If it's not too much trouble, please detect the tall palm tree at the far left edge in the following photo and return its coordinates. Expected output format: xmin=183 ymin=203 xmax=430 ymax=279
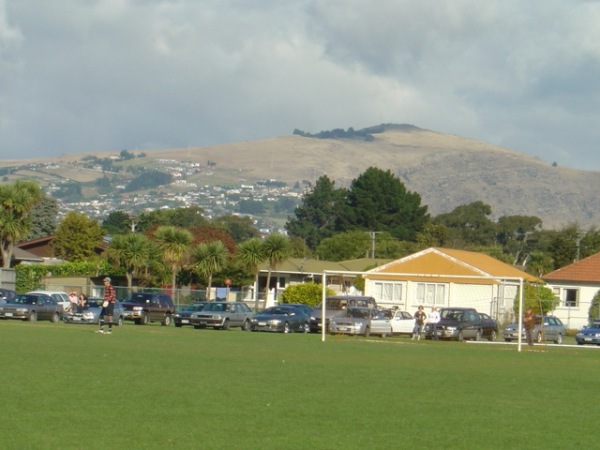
xmin=0 ymin=180 xmax=42 ymax=269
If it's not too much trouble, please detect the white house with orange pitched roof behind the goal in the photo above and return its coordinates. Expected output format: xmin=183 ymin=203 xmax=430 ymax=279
xmin=364 ymin=247 xmax=541 ymax=322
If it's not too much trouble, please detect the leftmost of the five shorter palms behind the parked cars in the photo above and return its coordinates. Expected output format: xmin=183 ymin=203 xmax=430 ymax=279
xmin=106 ymin=233 xmax=152 ymax=292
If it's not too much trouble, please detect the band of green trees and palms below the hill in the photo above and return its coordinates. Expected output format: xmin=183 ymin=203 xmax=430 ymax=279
xmin=0 ymin=167 xmax=600 ymax=294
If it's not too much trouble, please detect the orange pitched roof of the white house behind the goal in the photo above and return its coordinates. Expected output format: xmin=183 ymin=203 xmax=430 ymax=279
xmin=367 ymin=247 xmax=540 ymax=282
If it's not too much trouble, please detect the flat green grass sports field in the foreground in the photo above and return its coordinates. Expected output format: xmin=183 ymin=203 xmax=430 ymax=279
xmin=0 ymin=321 xmax=600 ymax=449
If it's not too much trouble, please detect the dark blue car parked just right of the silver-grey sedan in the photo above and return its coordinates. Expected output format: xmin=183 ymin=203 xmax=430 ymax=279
xmin=250 ymin=304 xmax=310 ymax=333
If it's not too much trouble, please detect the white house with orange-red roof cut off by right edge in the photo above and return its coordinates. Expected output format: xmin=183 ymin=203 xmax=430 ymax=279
xmin=542 ymin=253 xmax=600 ymax=328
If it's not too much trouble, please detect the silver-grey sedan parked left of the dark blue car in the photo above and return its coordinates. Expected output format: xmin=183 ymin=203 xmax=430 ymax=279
xmin=194 ymin=302 xmax=252 ymax=331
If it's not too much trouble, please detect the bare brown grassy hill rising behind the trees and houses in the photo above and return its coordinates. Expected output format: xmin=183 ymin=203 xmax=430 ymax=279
xmin=0 ymin=125 xmax=600 ymax=228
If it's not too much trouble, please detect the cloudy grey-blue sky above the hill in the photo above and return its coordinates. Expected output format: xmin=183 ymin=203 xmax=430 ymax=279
xmin=0 ymin=0 xmax=600 ymax=170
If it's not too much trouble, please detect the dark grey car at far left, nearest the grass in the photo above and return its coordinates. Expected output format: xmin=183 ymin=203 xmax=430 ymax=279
xmin=0 ymin=294 xmax=63 ymax=323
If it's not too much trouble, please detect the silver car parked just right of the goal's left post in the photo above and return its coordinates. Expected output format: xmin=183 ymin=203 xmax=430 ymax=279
xmin=329 ymin=307 xmax=392 ymax=337
